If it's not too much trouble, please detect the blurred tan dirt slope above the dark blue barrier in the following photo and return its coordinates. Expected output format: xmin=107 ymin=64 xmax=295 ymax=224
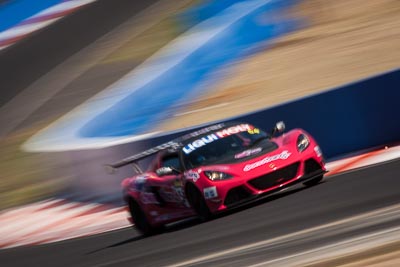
xmin=162 ymin=0 xmax=400 ymax=130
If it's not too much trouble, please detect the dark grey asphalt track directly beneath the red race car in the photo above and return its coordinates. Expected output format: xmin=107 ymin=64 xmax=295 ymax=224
xmin=0 ymin=160 xmax=400 ymax=266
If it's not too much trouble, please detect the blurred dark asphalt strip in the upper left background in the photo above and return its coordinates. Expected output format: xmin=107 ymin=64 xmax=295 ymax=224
xmin=0 ymin=0 xmax=157 ymax=107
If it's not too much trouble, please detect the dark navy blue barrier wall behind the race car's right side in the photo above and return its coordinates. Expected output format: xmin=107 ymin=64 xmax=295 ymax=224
xmin=240 ymin=70 xmax=400 ymax=158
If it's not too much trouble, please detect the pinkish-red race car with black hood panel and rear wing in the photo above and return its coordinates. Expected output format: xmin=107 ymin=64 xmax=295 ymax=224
xmin=109 ymin=122 xmax=326 ymax=235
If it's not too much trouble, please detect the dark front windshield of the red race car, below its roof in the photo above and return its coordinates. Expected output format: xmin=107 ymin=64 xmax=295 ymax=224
xmin=183 ymin=128 xmax=277 ymax=169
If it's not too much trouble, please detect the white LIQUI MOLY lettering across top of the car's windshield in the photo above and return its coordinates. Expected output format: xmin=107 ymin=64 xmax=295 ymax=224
xmin=182 ymin=124 xmax=255 ymax=154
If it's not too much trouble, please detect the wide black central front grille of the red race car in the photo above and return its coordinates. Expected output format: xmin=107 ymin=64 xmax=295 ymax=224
xmin=249 ymin=162 xmax=300 ymax=190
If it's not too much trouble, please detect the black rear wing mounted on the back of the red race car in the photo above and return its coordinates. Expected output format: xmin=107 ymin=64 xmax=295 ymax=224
xmin=105 ymin=141 xmax=181 ymax=173
